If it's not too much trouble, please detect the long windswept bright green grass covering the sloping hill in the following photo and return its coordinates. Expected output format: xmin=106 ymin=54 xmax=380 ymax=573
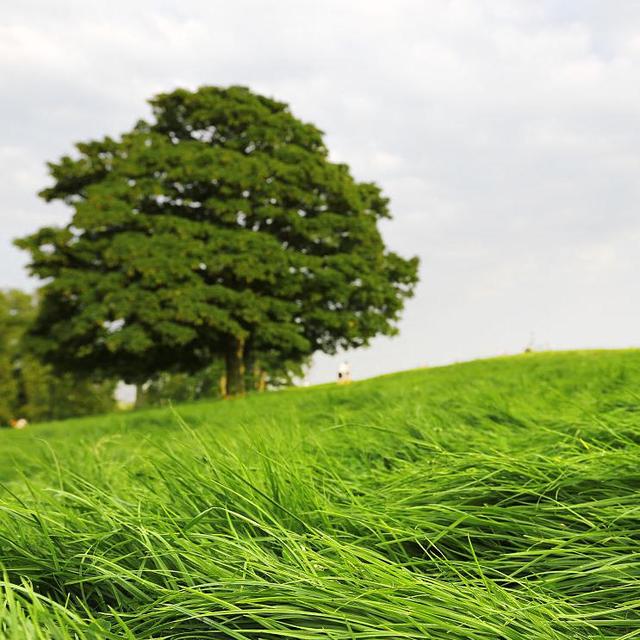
xmin=0 ymin=351 xmax=640 ymax=640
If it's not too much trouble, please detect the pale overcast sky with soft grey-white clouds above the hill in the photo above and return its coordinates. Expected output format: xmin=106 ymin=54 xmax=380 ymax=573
xmin=0 ymin=0 xmax=640 ymax=382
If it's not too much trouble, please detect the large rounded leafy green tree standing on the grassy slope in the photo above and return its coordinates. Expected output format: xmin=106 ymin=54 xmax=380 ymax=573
xmin=16 ymin=87 xmax=418 ymax=394
